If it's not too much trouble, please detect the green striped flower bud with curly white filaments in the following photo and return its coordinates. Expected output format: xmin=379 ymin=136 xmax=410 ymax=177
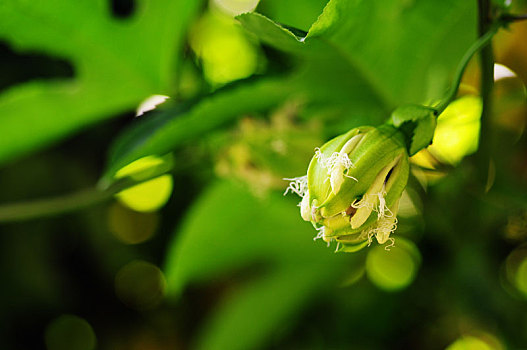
xmin=286 ymin=125 xmax=409 ymax=251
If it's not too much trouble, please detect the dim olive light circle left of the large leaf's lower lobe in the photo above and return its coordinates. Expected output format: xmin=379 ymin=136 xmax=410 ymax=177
xmin=115 ymin=260 xmax=166 ymax=310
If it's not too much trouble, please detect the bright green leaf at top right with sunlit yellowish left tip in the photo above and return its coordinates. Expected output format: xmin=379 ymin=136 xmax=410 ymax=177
xmin=305 ymin=0 xmax=477 ymax=105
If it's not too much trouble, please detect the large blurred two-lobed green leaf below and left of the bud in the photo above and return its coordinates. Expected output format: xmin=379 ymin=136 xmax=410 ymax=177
xmin=165 ymin=182 xmax=354 ymax=349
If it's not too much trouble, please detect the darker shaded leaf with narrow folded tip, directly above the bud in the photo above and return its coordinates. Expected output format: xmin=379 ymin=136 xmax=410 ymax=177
xmin=237 ymin=13 xmax=390 ymax=123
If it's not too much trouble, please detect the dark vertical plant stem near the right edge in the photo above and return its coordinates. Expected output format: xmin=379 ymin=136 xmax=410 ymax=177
xmin=477 ymin=0 xmax=500 ymax=192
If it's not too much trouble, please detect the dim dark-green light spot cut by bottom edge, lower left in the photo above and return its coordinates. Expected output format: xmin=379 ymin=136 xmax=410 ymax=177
xmin=44 ymin=315 xmax=97 ymax=350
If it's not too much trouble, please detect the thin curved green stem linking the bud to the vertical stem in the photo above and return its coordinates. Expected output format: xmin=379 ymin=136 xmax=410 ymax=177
xmin=435 ymin=21 xmax=502 ymax=115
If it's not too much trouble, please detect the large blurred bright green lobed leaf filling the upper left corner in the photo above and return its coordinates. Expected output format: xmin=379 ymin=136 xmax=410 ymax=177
xmin=0 ymin=0 xmax=201 ymax=163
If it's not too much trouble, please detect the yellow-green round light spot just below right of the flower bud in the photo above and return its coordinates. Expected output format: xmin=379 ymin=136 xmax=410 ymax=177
xmin=366 ymin=237 xmax=421 ymax=291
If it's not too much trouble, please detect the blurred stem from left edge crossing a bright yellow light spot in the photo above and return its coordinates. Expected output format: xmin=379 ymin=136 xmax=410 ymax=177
xmin=0 ymin=165 xmax=171 ymax=223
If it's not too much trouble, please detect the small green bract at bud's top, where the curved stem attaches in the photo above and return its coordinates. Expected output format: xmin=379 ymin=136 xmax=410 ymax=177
xmin=389 ymin=105 xmax=437 ymax=157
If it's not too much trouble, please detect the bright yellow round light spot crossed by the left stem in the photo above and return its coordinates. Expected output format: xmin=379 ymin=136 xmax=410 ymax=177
xmin=115 ymin=156 xmax=173 ymax=212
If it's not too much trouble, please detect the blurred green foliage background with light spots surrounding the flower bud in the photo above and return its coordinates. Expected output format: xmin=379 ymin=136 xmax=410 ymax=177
xmin=0 ymin=0 xmax=527 ymax=350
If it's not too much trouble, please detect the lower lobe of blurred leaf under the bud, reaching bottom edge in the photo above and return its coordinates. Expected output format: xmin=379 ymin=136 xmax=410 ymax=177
xmin=196 ymin=264 xmax=342 ymax=350
